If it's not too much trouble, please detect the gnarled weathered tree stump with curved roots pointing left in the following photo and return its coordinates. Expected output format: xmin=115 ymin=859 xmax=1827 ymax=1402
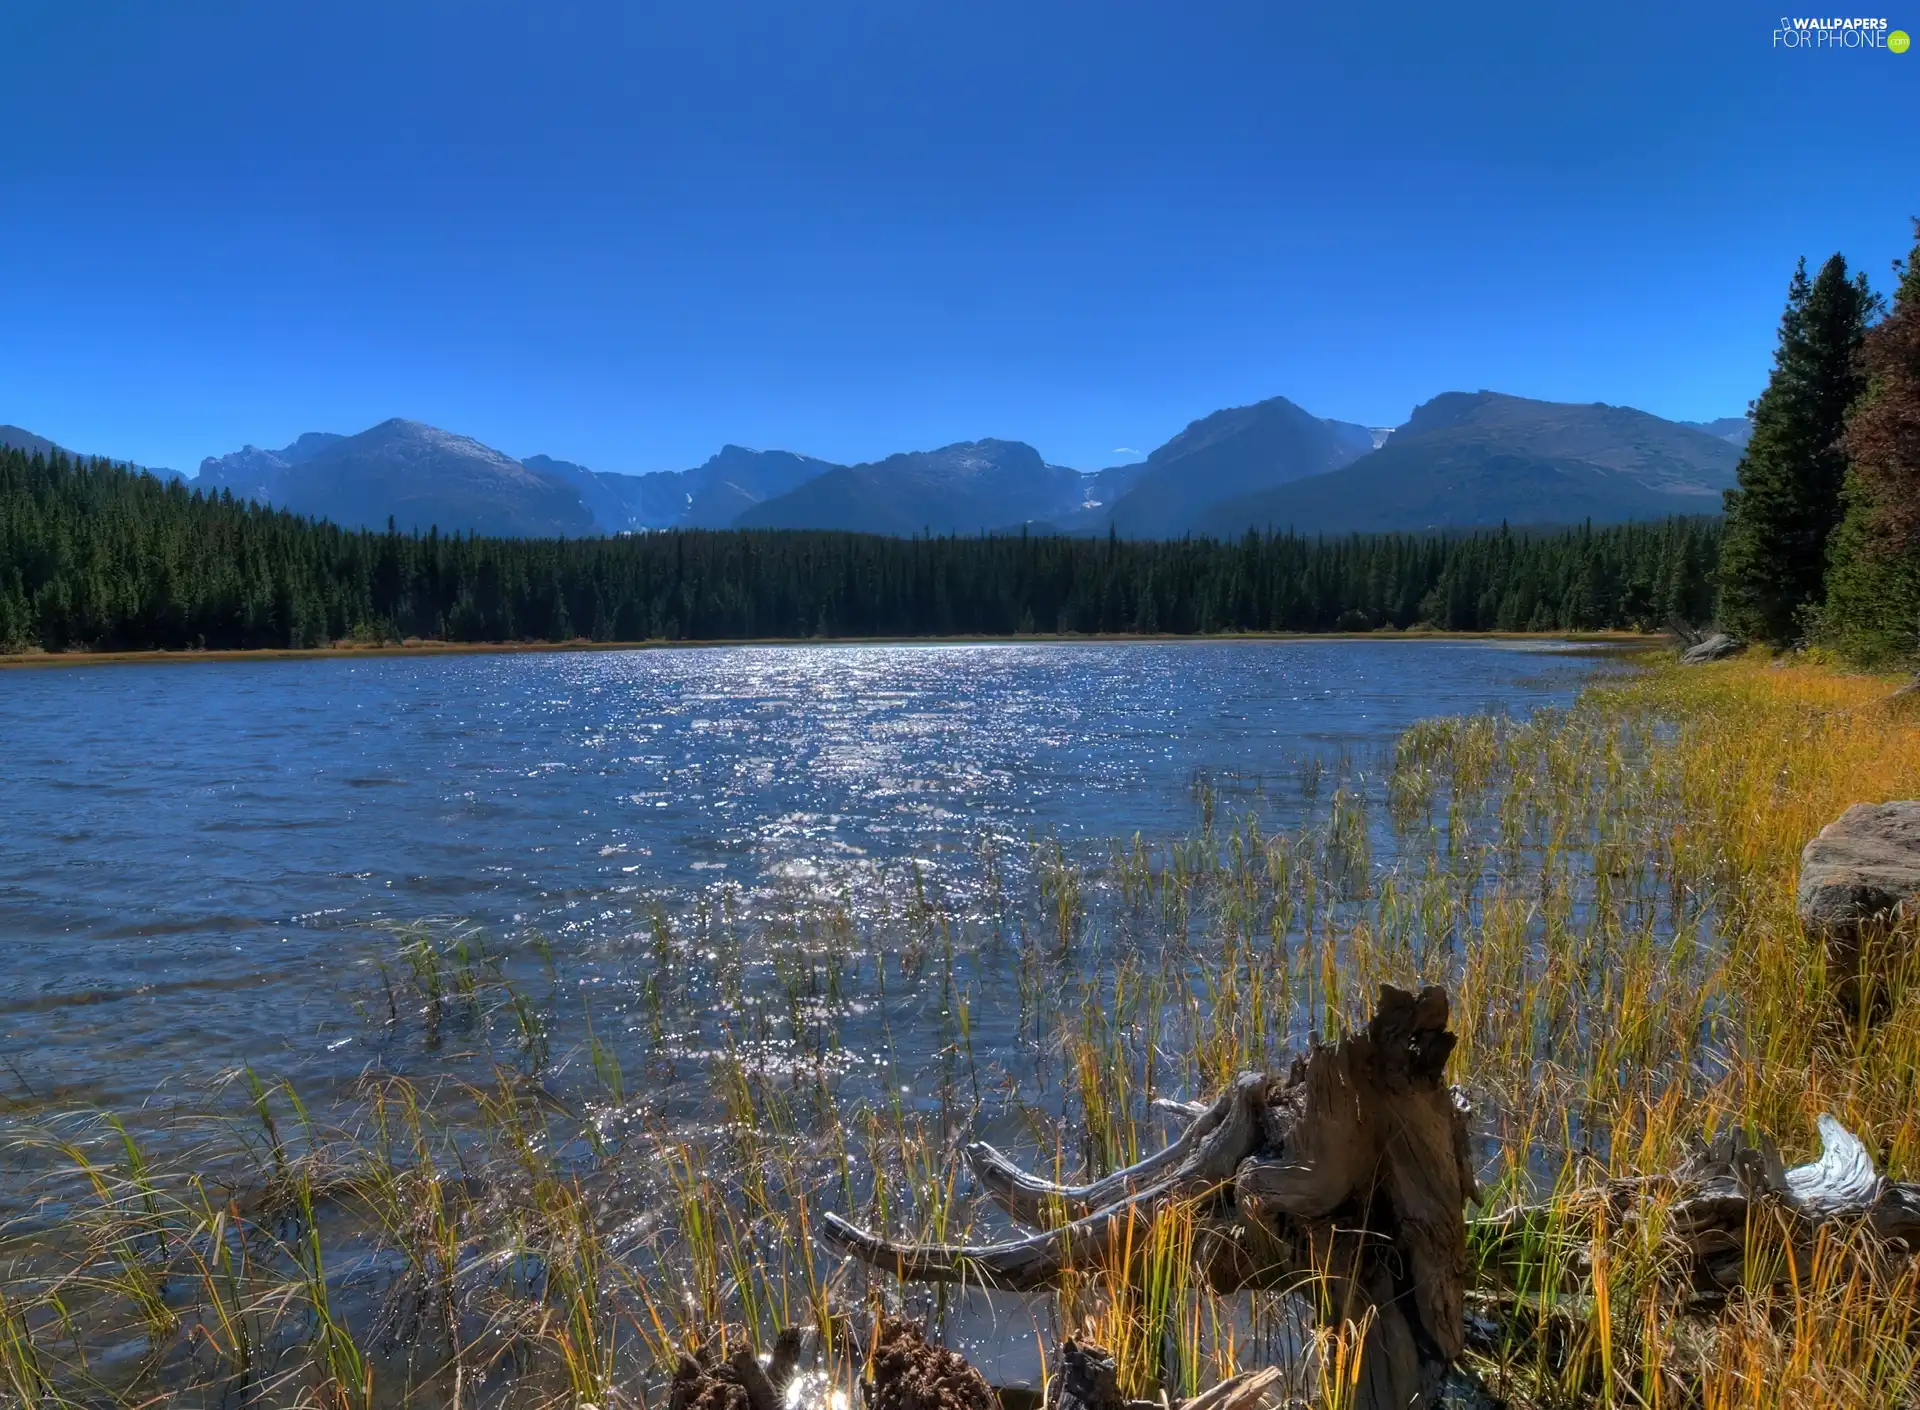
xmin=822 ymin=985 xmax=1475 ymax=1410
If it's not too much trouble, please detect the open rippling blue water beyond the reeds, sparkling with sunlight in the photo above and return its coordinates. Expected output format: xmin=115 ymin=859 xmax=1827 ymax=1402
xmin=0 ymin=642 xmax=1592 ymax=1106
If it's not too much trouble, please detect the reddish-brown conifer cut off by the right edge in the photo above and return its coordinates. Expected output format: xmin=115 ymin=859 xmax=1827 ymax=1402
xmin=1824 ymin=221 xmax=1920 ymax=665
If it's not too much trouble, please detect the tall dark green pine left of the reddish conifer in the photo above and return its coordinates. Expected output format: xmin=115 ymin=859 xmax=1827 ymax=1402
xmin=1720 ymin=255 xmax=1874 ymax=645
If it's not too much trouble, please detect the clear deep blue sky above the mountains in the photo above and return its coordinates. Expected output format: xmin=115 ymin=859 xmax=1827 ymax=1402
xmin=0 ymin=0 xmax=1920 ymax=471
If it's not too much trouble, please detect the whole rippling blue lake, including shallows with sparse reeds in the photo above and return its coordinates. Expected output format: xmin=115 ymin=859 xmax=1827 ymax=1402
xmin=0 ymin=642 xmax=1635 ymax=1404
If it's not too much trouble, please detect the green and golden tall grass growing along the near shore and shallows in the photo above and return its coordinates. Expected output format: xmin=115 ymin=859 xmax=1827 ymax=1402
xmin=0 ymin=661 xmax=1920 ymax=1406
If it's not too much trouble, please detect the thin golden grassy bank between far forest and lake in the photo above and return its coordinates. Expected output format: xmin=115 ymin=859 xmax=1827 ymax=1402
xmin=0 ymin=632 xmax=1665 ymax=670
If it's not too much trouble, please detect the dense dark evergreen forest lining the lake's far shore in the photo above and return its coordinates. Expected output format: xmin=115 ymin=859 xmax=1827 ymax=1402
xmin=0 ymin=451 xmax=1718 ymax=651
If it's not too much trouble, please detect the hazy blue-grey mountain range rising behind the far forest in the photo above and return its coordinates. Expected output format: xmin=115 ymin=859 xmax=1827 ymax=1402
xmin=0 ymin=392 xmax=1749 ymax=538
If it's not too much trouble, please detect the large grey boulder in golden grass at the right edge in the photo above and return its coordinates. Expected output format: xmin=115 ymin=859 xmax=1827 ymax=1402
xmin=1797 ymin=801 xmax=1920 ymax=997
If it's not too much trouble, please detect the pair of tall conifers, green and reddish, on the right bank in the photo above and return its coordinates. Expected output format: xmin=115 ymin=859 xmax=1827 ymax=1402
xmin=1720 ymin=223 xmax=1920 ymax=667
